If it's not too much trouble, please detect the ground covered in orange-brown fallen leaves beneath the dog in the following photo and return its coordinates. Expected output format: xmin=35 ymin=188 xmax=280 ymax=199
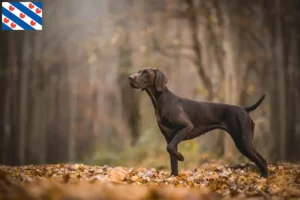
xmin=0 ymin=163 xmax=300 ymax=200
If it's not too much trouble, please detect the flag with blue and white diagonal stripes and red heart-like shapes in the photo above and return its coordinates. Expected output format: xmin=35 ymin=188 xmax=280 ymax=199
xmin=2 ymin=1 xmax=43 ymax=31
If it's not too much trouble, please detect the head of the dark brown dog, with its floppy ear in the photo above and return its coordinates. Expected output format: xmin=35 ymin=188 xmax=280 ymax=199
xmin=128 ymin=68 xmax=168 ymax=92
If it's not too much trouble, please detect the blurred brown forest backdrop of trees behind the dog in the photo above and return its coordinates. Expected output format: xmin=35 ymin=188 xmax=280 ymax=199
xmin=0 ymin=0 xmax=300 ymax=167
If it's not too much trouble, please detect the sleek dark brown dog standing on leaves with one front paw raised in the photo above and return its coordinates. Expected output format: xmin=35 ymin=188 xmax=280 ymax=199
xmin=128 ymin=68 xmax=268 ymax=178
